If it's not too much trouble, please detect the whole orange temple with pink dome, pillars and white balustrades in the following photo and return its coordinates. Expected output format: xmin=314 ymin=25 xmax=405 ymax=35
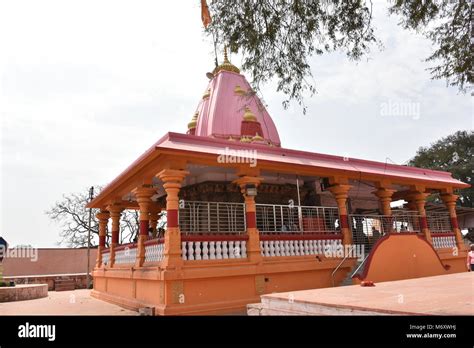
xmin=88 ymin=51 xmax=469 ymax=315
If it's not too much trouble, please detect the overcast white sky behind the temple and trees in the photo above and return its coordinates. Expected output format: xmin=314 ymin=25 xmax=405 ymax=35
xmin=0 ymin=0 xmax=473 ymax=247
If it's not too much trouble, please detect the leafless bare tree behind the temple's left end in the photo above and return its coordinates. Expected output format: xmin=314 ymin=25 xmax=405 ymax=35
xmin=46 ymin=186 xmax=143 ymax=248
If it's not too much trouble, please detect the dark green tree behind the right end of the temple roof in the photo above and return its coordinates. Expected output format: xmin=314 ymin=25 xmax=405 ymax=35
xmin=409 ymin=131 xmax=474 ymax=208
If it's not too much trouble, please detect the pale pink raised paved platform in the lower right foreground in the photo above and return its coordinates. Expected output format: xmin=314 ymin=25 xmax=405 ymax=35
xmin=249 ymin=272 xmax=474 ymax=315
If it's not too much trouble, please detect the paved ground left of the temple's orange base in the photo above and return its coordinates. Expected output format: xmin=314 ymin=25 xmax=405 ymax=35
xmin=0 ymin=290 xmax=138 ymax=315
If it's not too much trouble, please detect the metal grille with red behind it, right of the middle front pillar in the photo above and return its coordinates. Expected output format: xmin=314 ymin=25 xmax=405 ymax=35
xmin=256 ymin=204 xmax=339 ymax=233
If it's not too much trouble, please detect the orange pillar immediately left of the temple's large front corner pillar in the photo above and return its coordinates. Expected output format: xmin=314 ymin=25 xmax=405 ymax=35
xmin=134 ymin=185 xmax=156 ymax=267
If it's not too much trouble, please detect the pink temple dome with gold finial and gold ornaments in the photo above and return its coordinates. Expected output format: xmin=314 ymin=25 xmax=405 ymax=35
xmin=188 ymin=54 xmax=281 ymax=147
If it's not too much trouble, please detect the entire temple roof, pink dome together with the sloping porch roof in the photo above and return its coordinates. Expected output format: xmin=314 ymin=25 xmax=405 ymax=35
xmin=87 ymin=55 xmax=470 ymax=207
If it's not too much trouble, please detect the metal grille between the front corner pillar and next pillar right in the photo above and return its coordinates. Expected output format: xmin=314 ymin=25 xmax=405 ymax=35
xmin=179 ymin=201 xmax=246 ymax=234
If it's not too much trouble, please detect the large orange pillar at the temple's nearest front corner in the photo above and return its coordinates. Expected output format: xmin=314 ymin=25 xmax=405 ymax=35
xmin=157 ymin=169 xmax=189 ymax=268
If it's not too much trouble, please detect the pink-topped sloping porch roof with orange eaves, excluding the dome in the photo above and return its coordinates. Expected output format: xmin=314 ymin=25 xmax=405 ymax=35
xmin=87 ymin=133 xmax=470 ymax=207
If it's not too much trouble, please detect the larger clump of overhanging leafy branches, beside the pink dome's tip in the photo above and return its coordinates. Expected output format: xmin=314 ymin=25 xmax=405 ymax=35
xmin=208 ymin=0 xmax=375 ymax=110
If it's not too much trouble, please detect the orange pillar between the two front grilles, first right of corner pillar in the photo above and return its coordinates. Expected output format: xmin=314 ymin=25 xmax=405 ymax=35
xmin=234 ymin=175 xmax=262 ymax=263
